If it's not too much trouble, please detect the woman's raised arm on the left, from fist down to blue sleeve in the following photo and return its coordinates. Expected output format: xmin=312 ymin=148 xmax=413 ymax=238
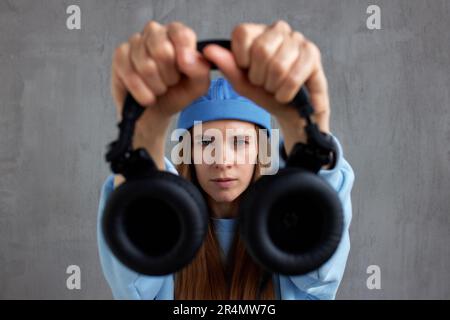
xmin=97 ymin=21 xmax=210 ymax=299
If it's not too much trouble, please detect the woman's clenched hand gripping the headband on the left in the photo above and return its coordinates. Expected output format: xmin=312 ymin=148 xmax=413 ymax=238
xmin=111 ymin=21 xmax=210 ymax=129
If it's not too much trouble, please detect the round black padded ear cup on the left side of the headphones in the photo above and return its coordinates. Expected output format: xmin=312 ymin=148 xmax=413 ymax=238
xmin=102 ymin=170 xmax=208 ymax=275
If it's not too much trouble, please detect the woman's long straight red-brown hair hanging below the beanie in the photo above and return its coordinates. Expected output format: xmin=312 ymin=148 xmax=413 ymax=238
xmin=174 ymin=125 xmax=275 ymax=300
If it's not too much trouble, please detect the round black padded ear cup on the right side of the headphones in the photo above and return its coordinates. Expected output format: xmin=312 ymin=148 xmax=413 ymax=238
xmin=239 ymin=168 xmax=343 ymax=275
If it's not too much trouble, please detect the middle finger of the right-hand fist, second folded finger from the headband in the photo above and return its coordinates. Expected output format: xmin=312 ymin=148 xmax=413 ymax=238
xmin=248 ymin=21 xmax=291 ymax=86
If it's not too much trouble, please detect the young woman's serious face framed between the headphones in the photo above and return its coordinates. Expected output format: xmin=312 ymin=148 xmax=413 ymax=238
xmin=192 ymin=120 xmax=258 ymax=202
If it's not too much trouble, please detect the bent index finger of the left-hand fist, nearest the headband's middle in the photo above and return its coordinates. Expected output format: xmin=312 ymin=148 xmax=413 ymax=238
xmin=168 ymin=22 xmax=211 ymax=79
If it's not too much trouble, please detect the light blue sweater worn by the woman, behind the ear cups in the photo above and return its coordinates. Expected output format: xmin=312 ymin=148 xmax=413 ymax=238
xmin=97 ymin=136 xmax=355 ymax=300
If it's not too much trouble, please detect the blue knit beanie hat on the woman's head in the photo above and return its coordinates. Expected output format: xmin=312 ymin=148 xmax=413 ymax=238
xmin=177 ymin=78 xmax=272 ymax=137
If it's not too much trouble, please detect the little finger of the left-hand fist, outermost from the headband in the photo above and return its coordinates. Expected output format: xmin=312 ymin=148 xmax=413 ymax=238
xmin=114 ymin=43 xmax=155 ymax=107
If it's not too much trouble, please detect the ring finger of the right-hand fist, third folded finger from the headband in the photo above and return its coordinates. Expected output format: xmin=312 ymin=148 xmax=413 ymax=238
xmin=264 ymin=32 xmax=301 ymax=93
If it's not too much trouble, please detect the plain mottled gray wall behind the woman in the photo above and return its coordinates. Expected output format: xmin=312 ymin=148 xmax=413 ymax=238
xmin=0 ymin=0 xmax=450 ymax=299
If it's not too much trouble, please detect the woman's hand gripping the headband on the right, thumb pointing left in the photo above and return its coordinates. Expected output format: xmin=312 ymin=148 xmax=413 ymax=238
xmin=203 ymin=20 xmax=330 ymax=154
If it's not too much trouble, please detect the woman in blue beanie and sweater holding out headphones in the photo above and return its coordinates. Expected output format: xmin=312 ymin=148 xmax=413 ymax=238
xmin=98 ymin=21 xmax=354 ymax=300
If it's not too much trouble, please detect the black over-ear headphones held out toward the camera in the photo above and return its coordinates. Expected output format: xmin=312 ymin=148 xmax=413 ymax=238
xmin=101 ymin=40 xmax=343 ymax=276
